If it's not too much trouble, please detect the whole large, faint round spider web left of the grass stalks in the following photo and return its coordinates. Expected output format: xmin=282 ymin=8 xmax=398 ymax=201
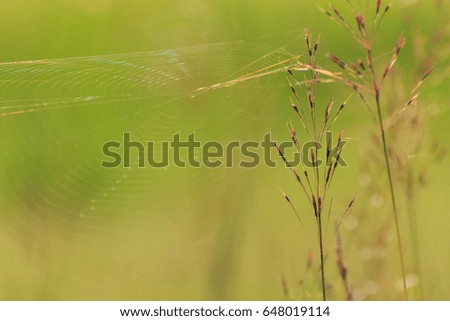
xmin=0 ymin=32 xmax=312 ymax=298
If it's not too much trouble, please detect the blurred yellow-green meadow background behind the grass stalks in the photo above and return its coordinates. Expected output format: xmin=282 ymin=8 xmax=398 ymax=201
xmin=0 ymin=0 xmax=450 ymax=300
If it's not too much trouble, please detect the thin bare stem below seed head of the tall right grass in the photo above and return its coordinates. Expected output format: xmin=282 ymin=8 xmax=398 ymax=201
xmin=375 ymin=90 xmax=408 ymax=300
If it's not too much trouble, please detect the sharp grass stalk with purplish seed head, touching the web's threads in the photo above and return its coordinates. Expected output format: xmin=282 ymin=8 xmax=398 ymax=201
xmin=275 ymin=31 xmax=351 ymax=301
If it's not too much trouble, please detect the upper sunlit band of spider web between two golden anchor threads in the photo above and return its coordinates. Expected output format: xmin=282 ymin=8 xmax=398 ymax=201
xmin=0 ymin=36 xmax=299 ymax=117
